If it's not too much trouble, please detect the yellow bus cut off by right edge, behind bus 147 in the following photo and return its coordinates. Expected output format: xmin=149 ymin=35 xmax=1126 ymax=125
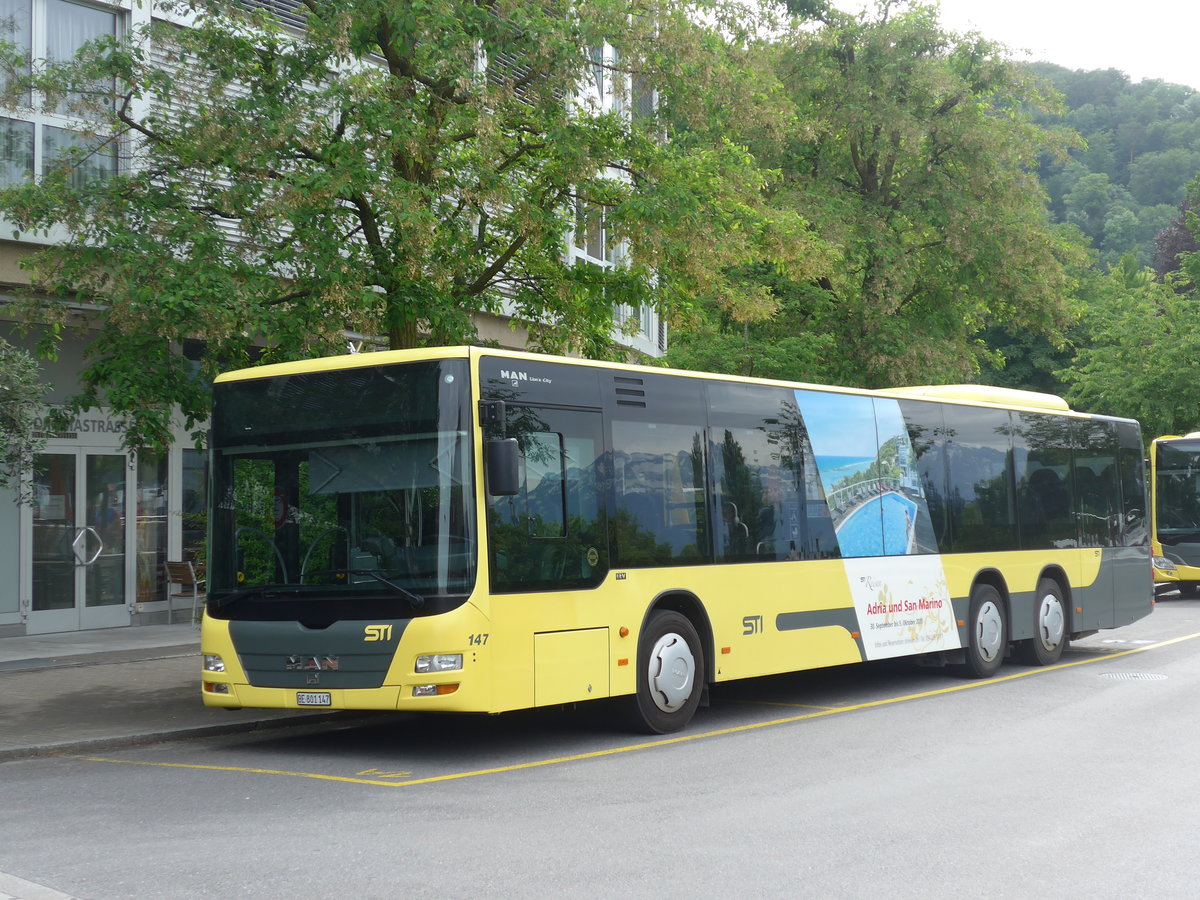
xmin=1150 ymin=431 xmax=1200 ymax=596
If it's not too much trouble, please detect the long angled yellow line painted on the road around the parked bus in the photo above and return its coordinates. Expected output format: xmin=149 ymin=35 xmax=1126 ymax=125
xmin=71 ymin=631 xmax=1200 ymax=787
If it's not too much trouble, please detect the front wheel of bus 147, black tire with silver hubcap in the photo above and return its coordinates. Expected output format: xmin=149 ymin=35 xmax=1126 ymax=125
xmin=630 ymin=610 xmax=704 ymax=734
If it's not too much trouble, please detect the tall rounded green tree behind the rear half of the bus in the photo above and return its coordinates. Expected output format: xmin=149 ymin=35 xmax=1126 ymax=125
xmin=672 ymin=1 xmax=1085 ymax=386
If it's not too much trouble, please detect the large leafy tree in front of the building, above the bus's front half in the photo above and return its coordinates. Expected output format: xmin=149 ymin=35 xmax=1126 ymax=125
xmin=0 ymin=0 xmax=816 ymax=446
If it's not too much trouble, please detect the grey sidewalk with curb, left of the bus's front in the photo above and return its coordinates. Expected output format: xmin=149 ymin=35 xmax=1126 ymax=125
xmin=0 ymin=624 xmax=350 ymax=762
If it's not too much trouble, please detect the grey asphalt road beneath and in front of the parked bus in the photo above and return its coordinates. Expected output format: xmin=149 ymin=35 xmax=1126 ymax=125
xmin=0 ymin=600 xmax=1200 ymax=900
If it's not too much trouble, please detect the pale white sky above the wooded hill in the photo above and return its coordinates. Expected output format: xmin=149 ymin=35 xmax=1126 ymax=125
xmin=834 ymin=0 xmax=1200 ymax=90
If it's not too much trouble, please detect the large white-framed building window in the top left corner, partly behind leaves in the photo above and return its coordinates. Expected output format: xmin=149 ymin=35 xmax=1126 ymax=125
xmin=0 ymin=0 xmax=120 ymax=187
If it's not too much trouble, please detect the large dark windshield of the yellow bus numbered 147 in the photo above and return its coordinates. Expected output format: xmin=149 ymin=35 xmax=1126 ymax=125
xmin=208 ymin=360 xmax=476 ymax=618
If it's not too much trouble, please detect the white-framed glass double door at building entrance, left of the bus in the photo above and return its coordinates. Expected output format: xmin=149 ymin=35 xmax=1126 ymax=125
xmin=28 ymin=450 xmax=132 ymax=634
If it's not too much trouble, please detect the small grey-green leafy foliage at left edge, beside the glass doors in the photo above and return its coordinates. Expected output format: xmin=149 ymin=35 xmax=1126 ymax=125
xmin=0 ymin=337 xmax=49 ymax=503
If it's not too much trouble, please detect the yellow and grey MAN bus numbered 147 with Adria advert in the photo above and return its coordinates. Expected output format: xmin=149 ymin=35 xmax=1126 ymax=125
xmin=202 ymin=347 xmax=1153 ymax=733
